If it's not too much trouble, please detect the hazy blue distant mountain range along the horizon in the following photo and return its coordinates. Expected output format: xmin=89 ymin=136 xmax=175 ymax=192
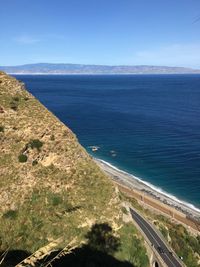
xmin=0 ymin=63 xmax=200 ymax=74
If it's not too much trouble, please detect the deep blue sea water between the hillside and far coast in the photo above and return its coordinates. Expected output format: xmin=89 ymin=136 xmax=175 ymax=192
xmin=16 ymin=75 xmax=200 ymax=208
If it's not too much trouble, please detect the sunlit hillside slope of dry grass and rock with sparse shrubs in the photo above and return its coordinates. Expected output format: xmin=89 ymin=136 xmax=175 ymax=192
xmin=0 ymin=72 xmax=120 ymax=251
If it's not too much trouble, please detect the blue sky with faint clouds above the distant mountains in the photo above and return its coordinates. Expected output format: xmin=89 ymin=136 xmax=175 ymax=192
xmin=0 ymin=0 xmax=200 ymax=68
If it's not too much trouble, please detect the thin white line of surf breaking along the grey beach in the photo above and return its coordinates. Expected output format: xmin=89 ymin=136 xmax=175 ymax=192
xmin=94 ymin=158 xmax=200 ymax=213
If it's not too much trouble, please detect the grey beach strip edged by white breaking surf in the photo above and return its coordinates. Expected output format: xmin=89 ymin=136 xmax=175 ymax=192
xmin=94 ymin=158 xmax=200 ymax=222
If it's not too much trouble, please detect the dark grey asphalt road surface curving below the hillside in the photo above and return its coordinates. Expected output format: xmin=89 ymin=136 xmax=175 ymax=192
xmin=130 ymin=209 xmax=182 ymax=267
